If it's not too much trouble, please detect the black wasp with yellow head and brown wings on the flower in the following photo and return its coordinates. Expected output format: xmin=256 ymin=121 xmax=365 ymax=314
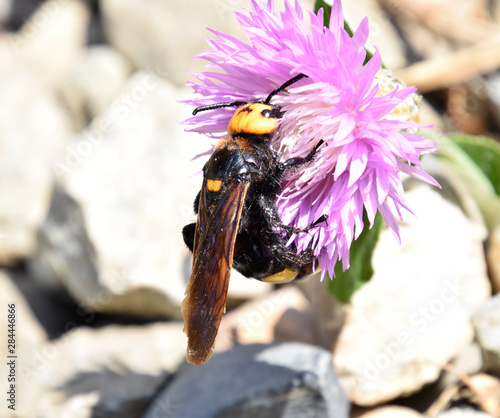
xmin=182 ymin=74 xmax=326 ymax=365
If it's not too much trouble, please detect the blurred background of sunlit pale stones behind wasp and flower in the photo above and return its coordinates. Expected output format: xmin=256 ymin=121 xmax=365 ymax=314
xmin=0 ymin=0 xmax=500 ymax=418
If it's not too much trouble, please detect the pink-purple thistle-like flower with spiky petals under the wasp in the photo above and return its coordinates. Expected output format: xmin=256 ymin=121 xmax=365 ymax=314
xmin=185 ymin=0 xmax=439 ymax=277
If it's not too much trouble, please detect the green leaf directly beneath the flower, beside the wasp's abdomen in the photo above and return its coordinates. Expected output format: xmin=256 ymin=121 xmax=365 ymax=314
xmin=328 ymin=213 xmax=384 ymax=303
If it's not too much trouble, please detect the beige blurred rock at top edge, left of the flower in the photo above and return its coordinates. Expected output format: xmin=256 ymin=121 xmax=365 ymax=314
xmin=100 ymin=0 xmax=314 ymax=85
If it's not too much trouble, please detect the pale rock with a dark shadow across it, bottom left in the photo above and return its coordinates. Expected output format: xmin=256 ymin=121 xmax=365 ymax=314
xmin=24 ymin=322 xmax=187 ymax=417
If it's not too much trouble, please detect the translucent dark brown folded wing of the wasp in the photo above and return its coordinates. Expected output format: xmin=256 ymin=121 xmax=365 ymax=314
xmin=182 ymin=179 xmax=249 ymax=365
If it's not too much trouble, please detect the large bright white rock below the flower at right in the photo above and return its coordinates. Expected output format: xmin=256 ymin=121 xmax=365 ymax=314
xmin=334 ymin=186 xmax=490 ymax=406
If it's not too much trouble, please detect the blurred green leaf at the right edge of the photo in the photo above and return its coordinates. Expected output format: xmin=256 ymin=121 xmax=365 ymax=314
xmin=449 ymin=133 xmax=500 ymax=196
